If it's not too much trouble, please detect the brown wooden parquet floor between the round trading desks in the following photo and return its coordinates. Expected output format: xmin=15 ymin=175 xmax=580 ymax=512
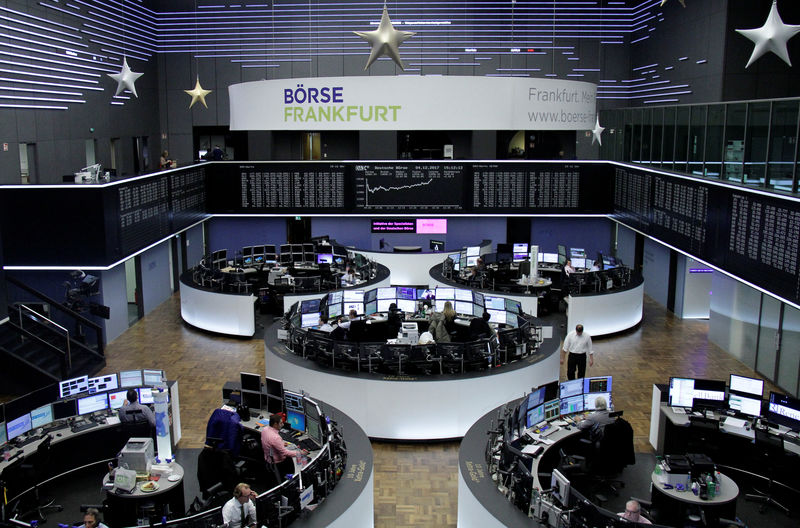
xmin=95 ymin=294 xmax=777 ymax=528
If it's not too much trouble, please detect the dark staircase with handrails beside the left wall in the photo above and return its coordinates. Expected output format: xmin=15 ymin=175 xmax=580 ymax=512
xmin=0 ymin=279 xmax=105 ymax=394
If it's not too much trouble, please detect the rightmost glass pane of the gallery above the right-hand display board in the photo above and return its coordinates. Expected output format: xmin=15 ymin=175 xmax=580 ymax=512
xmin=767 ymin=101 xmax=799 ymax=192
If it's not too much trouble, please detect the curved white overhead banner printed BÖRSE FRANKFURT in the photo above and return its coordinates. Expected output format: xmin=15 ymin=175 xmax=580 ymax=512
xmin=228 ymin=76 xmax=597 ymax=130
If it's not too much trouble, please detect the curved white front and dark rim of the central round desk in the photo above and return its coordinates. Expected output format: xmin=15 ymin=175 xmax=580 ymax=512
xmin=265 ymin=324 xmax=563 ymax=440
